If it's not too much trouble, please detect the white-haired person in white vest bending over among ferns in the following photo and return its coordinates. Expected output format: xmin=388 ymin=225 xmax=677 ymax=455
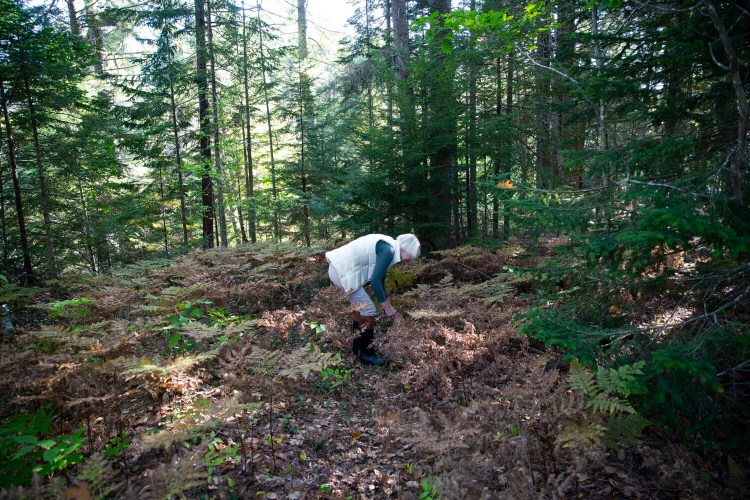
xmin=326 ymin=234 xmax=420 ymax=366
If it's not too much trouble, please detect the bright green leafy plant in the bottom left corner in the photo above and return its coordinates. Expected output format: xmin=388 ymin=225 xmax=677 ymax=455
xmin=0 ymin=410 xmax=86 ymax=487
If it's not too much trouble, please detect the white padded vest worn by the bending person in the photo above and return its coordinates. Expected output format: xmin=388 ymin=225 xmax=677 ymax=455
xmin=326 ymin=234 xmax=401 ymax=294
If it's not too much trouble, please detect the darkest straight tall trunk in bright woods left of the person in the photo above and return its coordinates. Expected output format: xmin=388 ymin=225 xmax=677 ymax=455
xmin=195 ymin=0 xmax=214 ymax=248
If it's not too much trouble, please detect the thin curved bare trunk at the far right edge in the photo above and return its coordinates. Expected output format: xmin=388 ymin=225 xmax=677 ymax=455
xmin=703 ymin=0 xmax=748 ymax=205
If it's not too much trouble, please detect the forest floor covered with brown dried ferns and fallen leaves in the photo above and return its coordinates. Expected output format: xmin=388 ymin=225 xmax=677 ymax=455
xmin=0 ymin=241 xmax=736 ymax=499
